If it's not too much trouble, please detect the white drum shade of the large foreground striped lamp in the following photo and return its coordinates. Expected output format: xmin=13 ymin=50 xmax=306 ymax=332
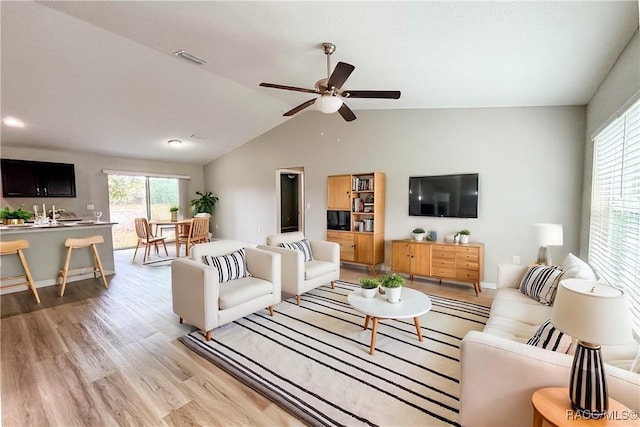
xmin=551 ymin=279 xmax=632 ymax=345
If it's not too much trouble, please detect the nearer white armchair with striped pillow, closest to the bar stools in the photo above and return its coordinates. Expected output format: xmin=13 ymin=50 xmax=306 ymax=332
xmin=171 ymin=240 xmax=281 ymax=341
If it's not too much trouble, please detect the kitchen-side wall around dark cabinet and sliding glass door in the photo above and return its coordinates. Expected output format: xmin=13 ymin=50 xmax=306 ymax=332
xmin=0 ymin=145 xmax=203 ymax=220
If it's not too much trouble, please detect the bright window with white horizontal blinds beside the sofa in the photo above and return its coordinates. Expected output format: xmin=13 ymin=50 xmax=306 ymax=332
xmin=589 ymin=100 xmax=640 ymax=336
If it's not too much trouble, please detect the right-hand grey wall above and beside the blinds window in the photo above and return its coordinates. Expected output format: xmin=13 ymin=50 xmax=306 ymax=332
xmin=580 ymin=30 xmax=640 ymax=260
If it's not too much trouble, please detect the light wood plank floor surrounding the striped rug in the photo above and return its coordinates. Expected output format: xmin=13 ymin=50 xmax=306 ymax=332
xmin=0 ymin=251 xmax=494 ymax=426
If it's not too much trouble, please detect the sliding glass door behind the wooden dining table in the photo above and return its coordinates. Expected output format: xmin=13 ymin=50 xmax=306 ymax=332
xmin=109 ymin=175 xmax=180 ymax=249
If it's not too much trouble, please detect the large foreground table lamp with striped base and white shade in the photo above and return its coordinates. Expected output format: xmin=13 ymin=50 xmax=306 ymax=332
xmin=551 ymin=279 xmax=632 ymax=419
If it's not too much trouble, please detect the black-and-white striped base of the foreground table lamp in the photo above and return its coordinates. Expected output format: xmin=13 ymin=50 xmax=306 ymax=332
xmin=569 ymin=341 xmax=609 ymax=419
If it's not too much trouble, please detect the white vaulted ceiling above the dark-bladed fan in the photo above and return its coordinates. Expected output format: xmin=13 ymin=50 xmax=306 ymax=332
xmin=0 ymin=0 xmax=638 ymax=164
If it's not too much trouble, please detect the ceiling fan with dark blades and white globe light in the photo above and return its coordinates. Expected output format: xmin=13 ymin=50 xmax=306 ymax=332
xmin=260 ymin=43 xmax=400 ymax=122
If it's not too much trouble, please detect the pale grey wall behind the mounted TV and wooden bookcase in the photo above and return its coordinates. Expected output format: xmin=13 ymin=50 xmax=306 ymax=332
xmin=204 ymin=107 xmax=585 ymax=282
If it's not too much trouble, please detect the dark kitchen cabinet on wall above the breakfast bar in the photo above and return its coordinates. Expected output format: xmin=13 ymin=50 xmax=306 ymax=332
xmin=2 ymin=159 xmax=76 ymax=197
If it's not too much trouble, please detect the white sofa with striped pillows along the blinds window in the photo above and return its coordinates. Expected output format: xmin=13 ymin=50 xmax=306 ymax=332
xmin=460 ymin=264 xmax=640 ymax=427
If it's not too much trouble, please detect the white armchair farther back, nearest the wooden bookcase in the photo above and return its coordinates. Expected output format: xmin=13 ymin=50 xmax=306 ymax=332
xmin=258 ymin=231 xmax=340 ymax=305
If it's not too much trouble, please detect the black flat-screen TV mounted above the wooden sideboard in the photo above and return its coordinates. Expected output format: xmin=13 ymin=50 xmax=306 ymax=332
xmin=409 ymin=173 xmax=478 ymax=218
